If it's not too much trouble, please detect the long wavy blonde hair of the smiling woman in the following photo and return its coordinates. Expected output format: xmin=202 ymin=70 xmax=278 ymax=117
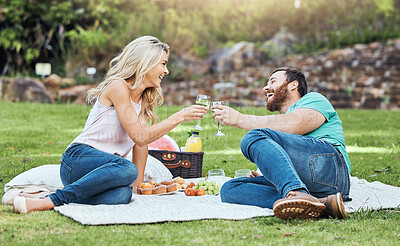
xmin=86 ymin=36 xmax=169 ymax=124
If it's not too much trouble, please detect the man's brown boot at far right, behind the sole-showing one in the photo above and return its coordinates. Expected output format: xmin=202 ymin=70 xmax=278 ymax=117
xmin=318 ymin=193 xmax=346 ymax=219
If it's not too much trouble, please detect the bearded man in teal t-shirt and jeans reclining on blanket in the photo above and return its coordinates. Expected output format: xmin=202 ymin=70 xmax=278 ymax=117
xmin=213 ymin=68 xmax=350 ymax=219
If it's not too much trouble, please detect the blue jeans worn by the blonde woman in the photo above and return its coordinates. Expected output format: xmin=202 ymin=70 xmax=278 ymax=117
xmin=49 ymin=143 xmax=138 ymax=206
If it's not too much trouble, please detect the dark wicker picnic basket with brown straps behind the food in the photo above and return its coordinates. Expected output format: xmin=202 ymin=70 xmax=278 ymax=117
xmin=149 ymin=150 xmax=204 ymax=178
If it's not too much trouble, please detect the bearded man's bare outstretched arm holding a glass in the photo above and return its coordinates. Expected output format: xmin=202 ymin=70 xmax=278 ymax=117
xmin=213 ymin=105 xmax=326 ymax=135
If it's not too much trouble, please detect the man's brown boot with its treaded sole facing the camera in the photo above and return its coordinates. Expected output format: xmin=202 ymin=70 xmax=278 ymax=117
xmin=273 ymin=191 xmax=325 ymax=220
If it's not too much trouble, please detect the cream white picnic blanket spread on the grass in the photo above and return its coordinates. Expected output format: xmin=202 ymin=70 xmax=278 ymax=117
xmin=55 ymin=177 xmax=400 ymax=225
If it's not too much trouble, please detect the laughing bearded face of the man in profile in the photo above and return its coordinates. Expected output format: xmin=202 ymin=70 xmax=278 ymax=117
xmin=263 ymin=71 xmax=289 ymax=111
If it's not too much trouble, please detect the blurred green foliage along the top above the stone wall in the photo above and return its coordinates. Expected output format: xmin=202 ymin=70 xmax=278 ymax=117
xmin=0 ymin=0 xmax=400 ymax=76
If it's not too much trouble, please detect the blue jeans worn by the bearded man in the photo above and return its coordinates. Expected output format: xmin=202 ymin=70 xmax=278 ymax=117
xmin=221 ymin=128 xmax=350 ymax=208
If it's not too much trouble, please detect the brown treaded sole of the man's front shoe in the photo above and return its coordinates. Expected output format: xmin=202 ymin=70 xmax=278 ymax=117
xmin=273 ymin=198 xmax=325 ymax=220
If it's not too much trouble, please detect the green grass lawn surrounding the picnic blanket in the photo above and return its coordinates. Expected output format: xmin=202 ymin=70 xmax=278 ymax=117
xmin=0 ymin=101 xmax=400 ymax=245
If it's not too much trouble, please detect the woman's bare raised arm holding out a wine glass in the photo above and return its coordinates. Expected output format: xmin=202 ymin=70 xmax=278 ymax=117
xmin=105 ymin=80 xmax=208 ymax=147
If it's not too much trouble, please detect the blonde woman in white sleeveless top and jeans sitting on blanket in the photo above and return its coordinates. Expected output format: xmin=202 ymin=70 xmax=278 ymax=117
xmin=14 ymin=36 xmax=208 ymax=213
